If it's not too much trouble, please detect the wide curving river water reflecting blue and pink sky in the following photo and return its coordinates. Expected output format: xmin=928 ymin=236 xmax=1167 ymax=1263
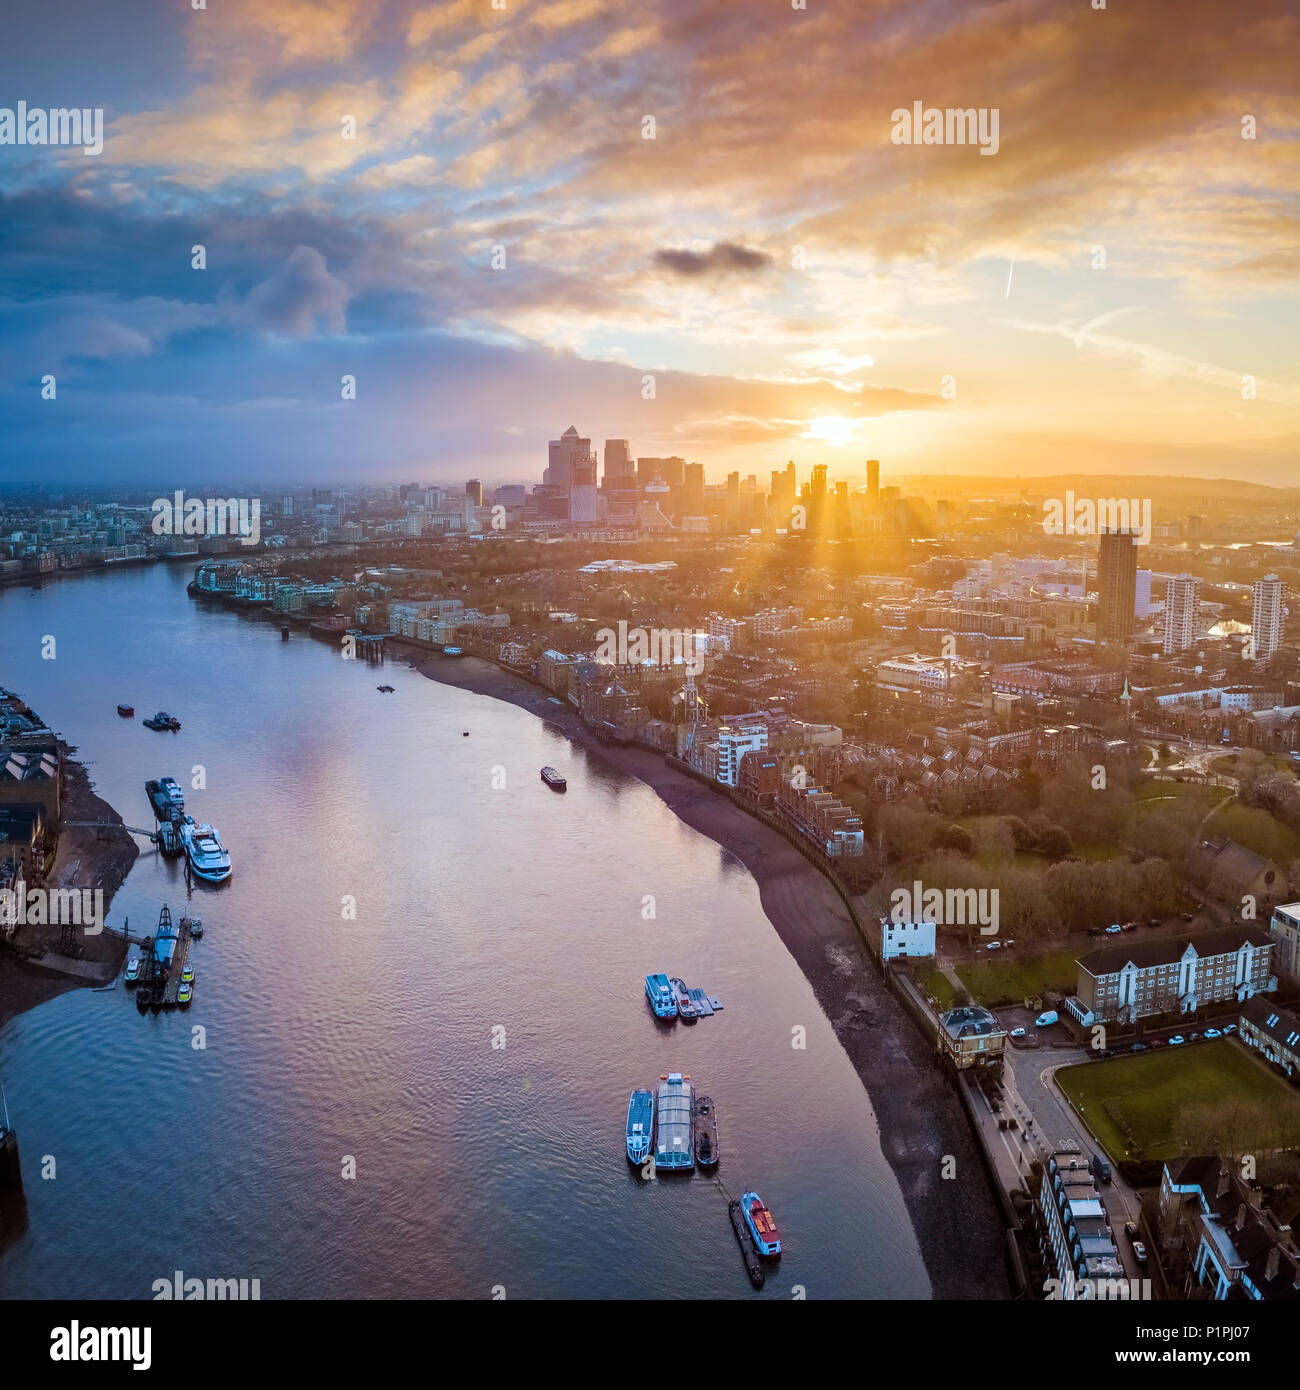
xmin=0 ymin=566 xmax=930 ymax=1298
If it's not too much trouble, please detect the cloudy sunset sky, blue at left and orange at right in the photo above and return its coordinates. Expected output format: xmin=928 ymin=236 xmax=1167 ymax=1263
xmin=0 ymin=0 xmax=1300 ymax=484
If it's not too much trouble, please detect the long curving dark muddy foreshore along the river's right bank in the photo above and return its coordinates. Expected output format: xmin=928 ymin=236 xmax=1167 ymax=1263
xmin=391 ymin=639 xmax=1011 ymax=1300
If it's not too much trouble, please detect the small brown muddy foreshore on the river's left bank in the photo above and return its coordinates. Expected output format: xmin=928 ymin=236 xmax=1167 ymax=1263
xmin=0 ymin=744 xmax=140 ymax=1030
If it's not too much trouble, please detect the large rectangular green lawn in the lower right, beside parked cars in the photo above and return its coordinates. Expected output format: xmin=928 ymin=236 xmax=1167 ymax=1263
xmin=1057 ymin=1038 xmax=1300 ymax=1162
